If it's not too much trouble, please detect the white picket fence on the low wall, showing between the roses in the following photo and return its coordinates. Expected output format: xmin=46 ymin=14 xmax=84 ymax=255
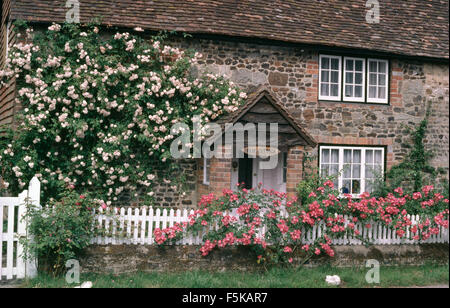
xmin=92 ymin=207 xmax=449 ymax=245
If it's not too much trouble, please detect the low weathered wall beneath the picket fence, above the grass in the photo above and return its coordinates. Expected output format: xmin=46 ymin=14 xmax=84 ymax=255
xmin=80 ymin=244 xmax=449 ymax=274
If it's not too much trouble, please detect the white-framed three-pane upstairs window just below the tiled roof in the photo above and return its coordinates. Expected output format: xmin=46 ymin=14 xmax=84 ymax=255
xmin=319 ymin=55 xmax=389 ymax=104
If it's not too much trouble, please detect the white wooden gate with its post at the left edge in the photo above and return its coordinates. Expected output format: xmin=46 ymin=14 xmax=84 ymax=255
xmin=0 ymin=177 xmax=41 ymax=280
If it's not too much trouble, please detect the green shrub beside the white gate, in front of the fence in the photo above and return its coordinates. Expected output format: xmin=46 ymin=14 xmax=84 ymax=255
xmin=22 ymin=184 xmax=97 ymax=275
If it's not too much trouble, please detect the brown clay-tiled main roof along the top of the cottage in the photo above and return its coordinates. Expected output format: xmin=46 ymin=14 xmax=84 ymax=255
xmin=11 ymin=0 xmax=449 ymax=59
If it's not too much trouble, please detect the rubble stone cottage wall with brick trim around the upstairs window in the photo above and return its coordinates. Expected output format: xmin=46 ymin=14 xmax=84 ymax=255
xmin=173 ymin=39 xmax=449 ymax=201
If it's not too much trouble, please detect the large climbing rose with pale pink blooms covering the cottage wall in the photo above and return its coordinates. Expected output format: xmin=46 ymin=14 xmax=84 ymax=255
xmin=0 ymin=24 xmax=245 ymax=205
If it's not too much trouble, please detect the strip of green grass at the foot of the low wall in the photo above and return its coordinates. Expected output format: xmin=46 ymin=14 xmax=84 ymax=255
xmin=22 ymin=265 xmax=449 ymax=288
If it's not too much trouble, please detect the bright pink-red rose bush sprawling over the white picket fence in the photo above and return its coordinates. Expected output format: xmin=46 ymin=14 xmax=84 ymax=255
xmin=154 ymin=181 xmax=449 ymax=264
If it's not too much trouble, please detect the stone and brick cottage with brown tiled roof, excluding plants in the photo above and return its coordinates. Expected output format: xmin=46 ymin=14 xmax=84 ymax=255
xmin=0 ymin=0 xmax=449 ymax=206
